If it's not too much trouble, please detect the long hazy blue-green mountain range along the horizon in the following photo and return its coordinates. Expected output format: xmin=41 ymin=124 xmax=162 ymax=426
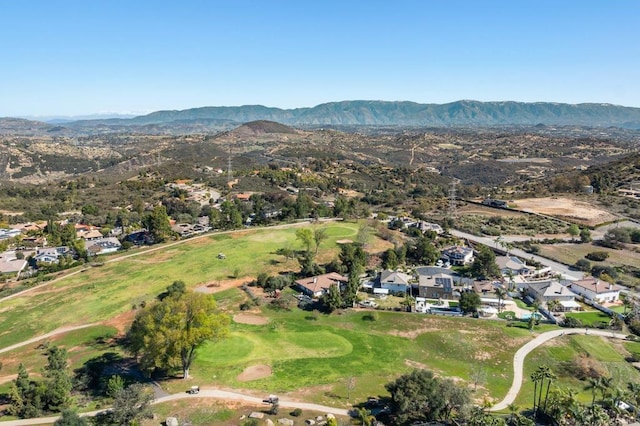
xmin=0 ymin=100 xmax=640 ymax=134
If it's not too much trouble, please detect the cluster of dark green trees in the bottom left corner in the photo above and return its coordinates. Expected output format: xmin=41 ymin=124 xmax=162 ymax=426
xmin=8 ymin=346 xmax=72 ymax=418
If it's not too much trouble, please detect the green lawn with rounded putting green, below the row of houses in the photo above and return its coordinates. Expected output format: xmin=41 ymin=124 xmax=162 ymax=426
xmin=176 ymin=307 xmax=533 ymax=405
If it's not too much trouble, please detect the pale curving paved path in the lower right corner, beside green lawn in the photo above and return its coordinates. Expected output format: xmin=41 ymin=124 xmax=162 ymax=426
xmin=491 ymin=328 xmax=627 ymax=411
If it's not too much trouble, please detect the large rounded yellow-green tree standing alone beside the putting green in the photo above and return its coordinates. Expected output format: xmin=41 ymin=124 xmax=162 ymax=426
xmin=127 ymin=292 xmax=230 ymax=379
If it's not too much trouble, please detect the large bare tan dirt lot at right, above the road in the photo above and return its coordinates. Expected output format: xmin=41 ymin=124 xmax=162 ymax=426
xmin=515 ymin=197 xmax=617 ymax=226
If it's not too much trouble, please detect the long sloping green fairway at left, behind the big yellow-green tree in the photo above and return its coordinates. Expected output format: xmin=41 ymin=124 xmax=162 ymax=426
xmin=0 ymin=222 xmax=359 ymax=348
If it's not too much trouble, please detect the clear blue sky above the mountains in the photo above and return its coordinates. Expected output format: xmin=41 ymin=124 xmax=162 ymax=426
xmin=0 ymin=0 xmax=640 ymax=116
